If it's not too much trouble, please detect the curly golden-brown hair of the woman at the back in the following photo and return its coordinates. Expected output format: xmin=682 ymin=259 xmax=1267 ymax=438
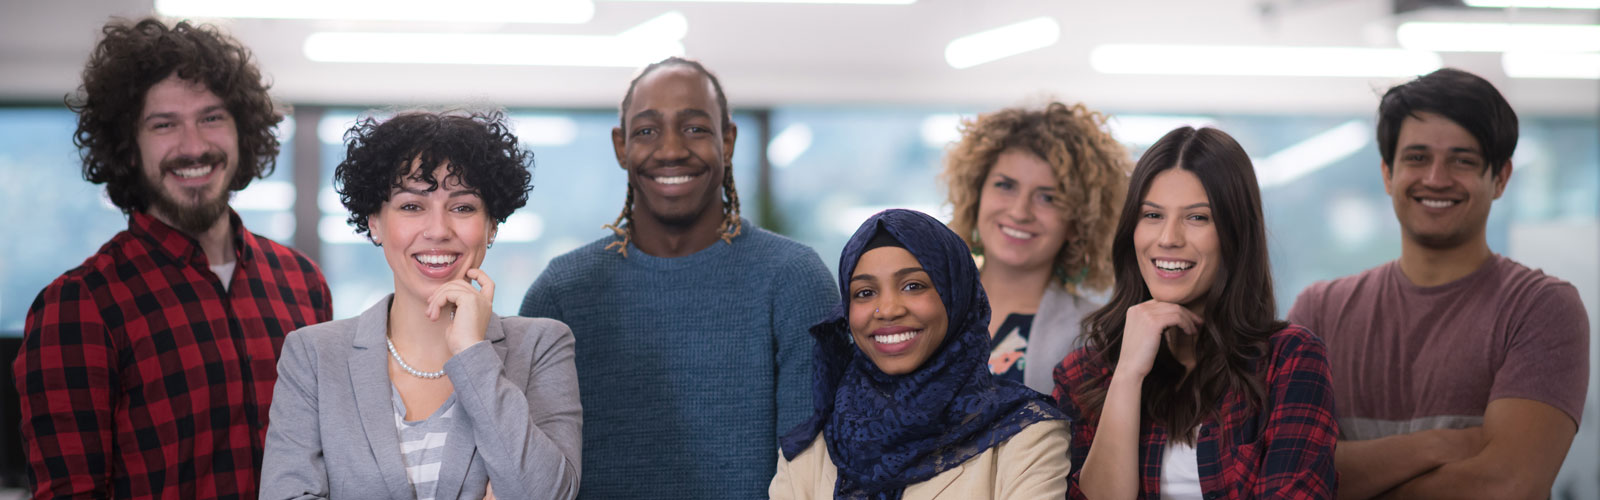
xmin=942 ymin=103 xmax=1133 ymax=295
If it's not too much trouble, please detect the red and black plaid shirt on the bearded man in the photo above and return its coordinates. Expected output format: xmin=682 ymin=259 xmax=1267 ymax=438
xmin=13 ymin=213 xmax=333 ymax=500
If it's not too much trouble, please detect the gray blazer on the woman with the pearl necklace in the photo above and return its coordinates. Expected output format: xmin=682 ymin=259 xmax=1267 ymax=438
xmin=261 ymin=296 xmax=582 ymax=500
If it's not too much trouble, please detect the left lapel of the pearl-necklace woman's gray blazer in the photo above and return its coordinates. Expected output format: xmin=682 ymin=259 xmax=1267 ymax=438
xmin=350 ymin=295 xmax=416 ymax=498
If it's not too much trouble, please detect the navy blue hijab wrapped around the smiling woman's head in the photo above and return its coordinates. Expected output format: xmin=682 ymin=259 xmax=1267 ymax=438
xmin=779 ymin=210 xmax=1064 ymax=498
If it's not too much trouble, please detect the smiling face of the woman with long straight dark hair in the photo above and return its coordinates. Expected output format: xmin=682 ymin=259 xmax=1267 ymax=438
xmin=1133 ymin=168 xmax=1222 ymax=309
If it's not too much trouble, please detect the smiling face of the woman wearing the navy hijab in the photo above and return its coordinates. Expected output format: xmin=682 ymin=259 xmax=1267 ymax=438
xmin=850 ymin=247 xmax=950 ymax=375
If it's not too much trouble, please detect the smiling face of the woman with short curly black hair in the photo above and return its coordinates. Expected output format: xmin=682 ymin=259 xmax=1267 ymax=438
xmin=368 ymin=163 xmax=494 ymax=301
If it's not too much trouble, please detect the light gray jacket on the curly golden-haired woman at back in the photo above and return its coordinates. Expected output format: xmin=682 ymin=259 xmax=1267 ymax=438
xmin=1024 ymin=284 xmax=1101 ymax=394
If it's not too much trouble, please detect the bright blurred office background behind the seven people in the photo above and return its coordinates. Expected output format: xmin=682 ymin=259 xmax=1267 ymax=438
xmin=0 ymin=0 xmax=1600 ymax=498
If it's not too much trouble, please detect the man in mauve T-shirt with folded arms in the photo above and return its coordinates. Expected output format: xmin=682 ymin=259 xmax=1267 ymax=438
xmin=1288 ymin=69 xmax=1589 ymax=498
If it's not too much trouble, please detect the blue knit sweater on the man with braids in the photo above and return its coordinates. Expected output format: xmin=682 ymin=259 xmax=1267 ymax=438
xmin=522 ymin=221 xmax=838 ymax=498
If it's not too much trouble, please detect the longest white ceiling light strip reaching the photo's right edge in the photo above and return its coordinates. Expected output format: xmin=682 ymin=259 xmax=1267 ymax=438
xmin=1395 ymin=22 xmax=1600 ymax=51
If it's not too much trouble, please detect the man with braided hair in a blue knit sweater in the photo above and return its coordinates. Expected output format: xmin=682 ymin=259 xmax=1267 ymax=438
xmin=522 ymin=58 xmax=838 ymax=498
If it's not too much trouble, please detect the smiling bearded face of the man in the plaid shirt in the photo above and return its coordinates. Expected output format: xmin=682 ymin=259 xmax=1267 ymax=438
xmin=134 ymin=74 xmax=238 ymax=232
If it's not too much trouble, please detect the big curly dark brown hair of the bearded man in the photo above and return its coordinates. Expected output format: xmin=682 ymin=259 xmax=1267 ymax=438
xmin=66 ymin=18 xmax=283 ymax=213
